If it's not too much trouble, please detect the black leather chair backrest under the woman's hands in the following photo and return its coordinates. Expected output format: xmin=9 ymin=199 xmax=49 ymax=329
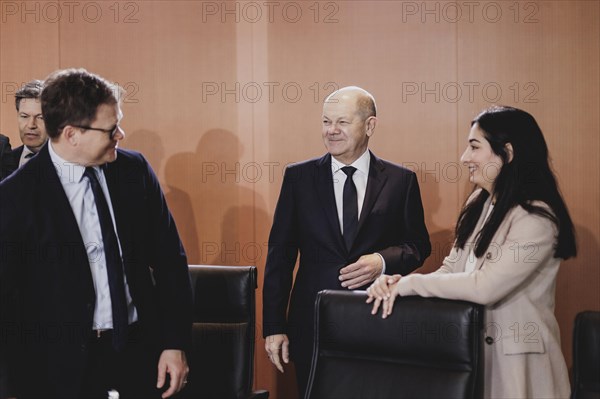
xmin=306 ymin=290 xmax=483 ymax=399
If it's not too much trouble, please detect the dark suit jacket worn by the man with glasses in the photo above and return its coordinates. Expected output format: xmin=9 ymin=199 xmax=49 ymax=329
xmin=0 ymin=145 xmax=192 ymax=398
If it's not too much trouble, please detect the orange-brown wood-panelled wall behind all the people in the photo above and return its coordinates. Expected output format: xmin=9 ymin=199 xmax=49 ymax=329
xmin=0 ymin=0 xmax=600 ymax=399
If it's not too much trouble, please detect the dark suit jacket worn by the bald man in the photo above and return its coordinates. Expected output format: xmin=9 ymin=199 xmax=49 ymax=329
xmin=263 ymin=154 xmax=431 ymax=359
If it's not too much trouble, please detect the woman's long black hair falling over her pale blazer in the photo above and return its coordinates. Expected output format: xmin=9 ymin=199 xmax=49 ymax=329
xmin=455 ymin=106 xmax=577 ymax=259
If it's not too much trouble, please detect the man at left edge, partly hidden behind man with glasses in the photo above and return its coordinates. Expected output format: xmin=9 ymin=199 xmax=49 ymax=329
xmin=2 ymin=80 xmax=48 ymax=177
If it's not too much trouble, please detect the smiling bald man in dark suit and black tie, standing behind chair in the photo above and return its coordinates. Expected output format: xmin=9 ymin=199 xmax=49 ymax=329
xmin=263 ymin=87 xmax=431 ymax=396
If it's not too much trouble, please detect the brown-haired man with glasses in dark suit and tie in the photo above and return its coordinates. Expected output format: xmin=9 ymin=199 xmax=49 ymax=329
xmin=0 ymin=69 xmax=192 ymax=399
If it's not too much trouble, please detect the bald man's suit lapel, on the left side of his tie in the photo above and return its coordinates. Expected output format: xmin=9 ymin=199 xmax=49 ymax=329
xmin=315 ymin=154 xmax=345 ymax=248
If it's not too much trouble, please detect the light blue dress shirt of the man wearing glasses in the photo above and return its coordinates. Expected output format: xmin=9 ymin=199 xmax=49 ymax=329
xmin=48 ymin=142 xmax=137 ymax=330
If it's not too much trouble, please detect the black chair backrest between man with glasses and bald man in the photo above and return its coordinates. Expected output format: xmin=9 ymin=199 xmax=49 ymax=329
xmin=183 ymin=265 xmax=257 ymax=398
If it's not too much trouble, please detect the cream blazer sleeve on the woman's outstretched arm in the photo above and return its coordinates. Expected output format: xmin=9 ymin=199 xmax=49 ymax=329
xmin=398 ymin=209 xmax=556 ymax=305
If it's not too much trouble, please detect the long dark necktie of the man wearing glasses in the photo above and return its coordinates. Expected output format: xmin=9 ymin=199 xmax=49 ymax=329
xmin=83 ymin=168 xmax=129 ymax=351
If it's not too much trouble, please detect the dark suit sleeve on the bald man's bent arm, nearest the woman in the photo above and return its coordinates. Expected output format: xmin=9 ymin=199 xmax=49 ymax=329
xmin=377 ymin=173 xmax=431 ymax=275
